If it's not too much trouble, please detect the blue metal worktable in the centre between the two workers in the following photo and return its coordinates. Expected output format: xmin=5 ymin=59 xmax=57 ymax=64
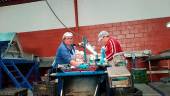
xmin=51 ymin=70 xmax=107 ymax=96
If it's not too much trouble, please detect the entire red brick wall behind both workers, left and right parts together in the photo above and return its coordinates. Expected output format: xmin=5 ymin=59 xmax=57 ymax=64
xmin=19 ymin=17 xmax=170 ymax=56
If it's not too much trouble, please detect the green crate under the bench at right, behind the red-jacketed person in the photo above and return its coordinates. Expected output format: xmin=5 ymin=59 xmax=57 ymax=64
xmin=132 ymin=68 xmax=148 ymax=83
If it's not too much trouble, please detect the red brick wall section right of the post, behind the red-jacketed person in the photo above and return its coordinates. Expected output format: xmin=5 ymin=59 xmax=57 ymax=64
xmin=80 ymin=17 xmax=170 ymax=53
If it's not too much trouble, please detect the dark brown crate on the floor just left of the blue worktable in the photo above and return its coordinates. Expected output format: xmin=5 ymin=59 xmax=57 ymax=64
xmin=33 ymin=81 xmax=57 ymax=96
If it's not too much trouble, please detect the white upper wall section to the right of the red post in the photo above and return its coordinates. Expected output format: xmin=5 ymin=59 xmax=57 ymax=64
xmin=79 ymin=0 xmax=170 ymax=26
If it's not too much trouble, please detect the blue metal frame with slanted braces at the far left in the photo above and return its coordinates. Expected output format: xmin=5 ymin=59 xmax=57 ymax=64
xmin=0 ymin=32 xmax=40 ymax=89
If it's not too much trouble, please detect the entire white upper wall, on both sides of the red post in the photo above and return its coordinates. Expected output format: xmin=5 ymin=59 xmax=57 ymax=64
xmin=0 ymin=0 xmax=170 ymax=32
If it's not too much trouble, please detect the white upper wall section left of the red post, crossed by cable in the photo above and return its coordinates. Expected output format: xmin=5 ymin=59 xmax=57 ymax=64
xmin=0 ymin=0 xmax=74 ymax=32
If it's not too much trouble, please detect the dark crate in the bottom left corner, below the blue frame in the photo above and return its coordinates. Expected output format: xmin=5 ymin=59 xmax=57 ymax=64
xmin=0 ymin=88 xmax=28 ymax=96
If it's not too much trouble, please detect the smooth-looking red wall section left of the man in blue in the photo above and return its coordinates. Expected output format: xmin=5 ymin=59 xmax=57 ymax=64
xmin=18 ymin=29 xmax=79 ymax=57
